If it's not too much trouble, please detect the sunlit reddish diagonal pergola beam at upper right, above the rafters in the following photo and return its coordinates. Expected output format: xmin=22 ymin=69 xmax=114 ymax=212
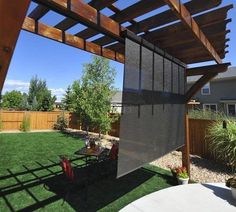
xmin=165 ymin=0 xmax=222 ymax=64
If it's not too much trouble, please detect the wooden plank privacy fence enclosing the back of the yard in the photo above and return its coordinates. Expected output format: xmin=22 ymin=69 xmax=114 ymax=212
xmin=0 ymin=111 xmax=218 ymax=158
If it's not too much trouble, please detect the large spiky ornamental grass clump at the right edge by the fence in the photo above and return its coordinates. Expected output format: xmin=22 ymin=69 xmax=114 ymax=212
xmin=207 ymin=119 xmax=236 ymax=170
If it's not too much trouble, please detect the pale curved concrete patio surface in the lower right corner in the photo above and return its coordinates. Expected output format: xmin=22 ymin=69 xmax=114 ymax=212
xmin=120 ymin=183 xmax=236 ymax=212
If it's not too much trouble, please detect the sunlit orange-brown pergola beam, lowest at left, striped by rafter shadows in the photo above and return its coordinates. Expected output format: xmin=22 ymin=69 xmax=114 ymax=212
xmin=22 ymin=17 xmax=124 ymax=63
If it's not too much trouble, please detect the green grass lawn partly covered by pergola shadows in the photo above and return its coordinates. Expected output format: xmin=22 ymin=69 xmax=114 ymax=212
xmin=0 ymin=132 xmax=174 ymax=212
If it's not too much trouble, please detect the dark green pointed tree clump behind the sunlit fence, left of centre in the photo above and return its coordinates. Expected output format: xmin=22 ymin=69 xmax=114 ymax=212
xmin=28 ymin=76 xmax=56 ymax=111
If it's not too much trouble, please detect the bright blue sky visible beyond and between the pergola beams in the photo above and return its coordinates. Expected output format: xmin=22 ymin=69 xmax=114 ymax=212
xmin=3 ymin=0 xmax=236 ymax=100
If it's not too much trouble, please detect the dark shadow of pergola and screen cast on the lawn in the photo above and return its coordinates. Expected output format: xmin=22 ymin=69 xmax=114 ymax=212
xmin=0 ymin=159 xmax=174 ymax=211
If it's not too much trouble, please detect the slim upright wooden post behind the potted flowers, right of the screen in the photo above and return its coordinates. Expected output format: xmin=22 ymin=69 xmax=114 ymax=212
xmin=182 ymin=113 xmax=190 ymax=177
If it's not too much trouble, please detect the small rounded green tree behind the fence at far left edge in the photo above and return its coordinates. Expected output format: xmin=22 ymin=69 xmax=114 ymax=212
xmin=2 ymin=90 xmax=23 ymax=110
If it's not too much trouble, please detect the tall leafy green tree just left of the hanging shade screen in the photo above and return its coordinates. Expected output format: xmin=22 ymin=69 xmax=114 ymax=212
xmin=77 ymin=56 xmax=116 ymax=135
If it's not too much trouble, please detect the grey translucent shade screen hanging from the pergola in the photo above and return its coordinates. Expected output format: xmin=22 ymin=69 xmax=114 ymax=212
xmin=117 ymin=38 xmax=186 ymax=177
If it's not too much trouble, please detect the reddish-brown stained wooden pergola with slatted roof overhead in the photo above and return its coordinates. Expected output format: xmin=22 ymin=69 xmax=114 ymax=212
xmin=0 ymin=0 xmax=233 ymax=174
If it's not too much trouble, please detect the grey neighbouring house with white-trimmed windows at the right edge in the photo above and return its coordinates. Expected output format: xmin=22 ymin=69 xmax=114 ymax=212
xmin=188 ymin=67 xmax=236 ymax=116
